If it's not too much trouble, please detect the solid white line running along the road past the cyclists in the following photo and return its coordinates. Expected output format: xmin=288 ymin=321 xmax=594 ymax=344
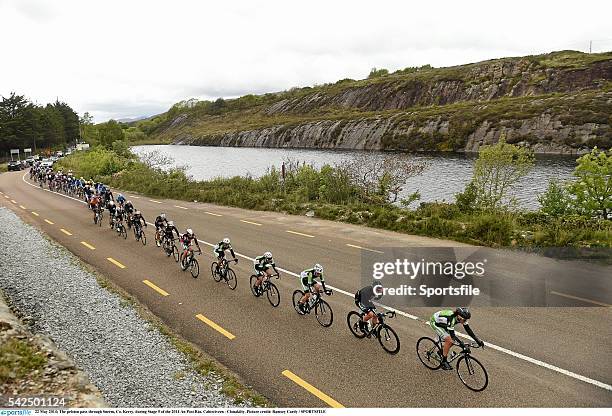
xmin=21 ymin=173 xmax=612 ymax=391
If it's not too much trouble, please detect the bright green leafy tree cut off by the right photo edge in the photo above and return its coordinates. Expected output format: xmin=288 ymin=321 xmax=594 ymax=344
xmin=569 ymin=147 xmax=612 ymax=218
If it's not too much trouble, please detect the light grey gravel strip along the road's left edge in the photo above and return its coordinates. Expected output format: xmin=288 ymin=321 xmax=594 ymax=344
xmin=0 ymin=207 xmax=265 ymax=407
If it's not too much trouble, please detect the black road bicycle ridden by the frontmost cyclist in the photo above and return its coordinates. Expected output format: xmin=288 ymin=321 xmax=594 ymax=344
xmin=416 ymin=337 xmax=489 ymax=391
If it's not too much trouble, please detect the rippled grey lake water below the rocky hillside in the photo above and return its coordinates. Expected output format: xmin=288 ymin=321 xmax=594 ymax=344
xmin=132 ymin=145 xmax=576 ymax=209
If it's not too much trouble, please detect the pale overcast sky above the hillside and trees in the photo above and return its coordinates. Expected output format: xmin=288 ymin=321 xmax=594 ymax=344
xmin=0 ymin=0 xmax=612 ymax=122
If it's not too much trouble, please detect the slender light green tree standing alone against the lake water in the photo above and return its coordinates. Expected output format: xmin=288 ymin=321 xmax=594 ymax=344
xmin=472 ymin=137 xmax=535 ymax=210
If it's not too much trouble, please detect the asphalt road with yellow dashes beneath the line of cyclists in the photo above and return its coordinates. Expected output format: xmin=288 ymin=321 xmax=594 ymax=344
xmin=0 ymin=172 xmax=612 ymax=407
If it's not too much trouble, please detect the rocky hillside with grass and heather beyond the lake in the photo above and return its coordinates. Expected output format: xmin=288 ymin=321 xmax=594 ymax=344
xmin=145 ymin=51 xmax=612 ymax=153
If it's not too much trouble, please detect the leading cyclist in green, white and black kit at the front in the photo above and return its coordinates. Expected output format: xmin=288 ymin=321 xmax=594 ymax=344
xmin=429 ymin=307 xmax=484 ymax=370
